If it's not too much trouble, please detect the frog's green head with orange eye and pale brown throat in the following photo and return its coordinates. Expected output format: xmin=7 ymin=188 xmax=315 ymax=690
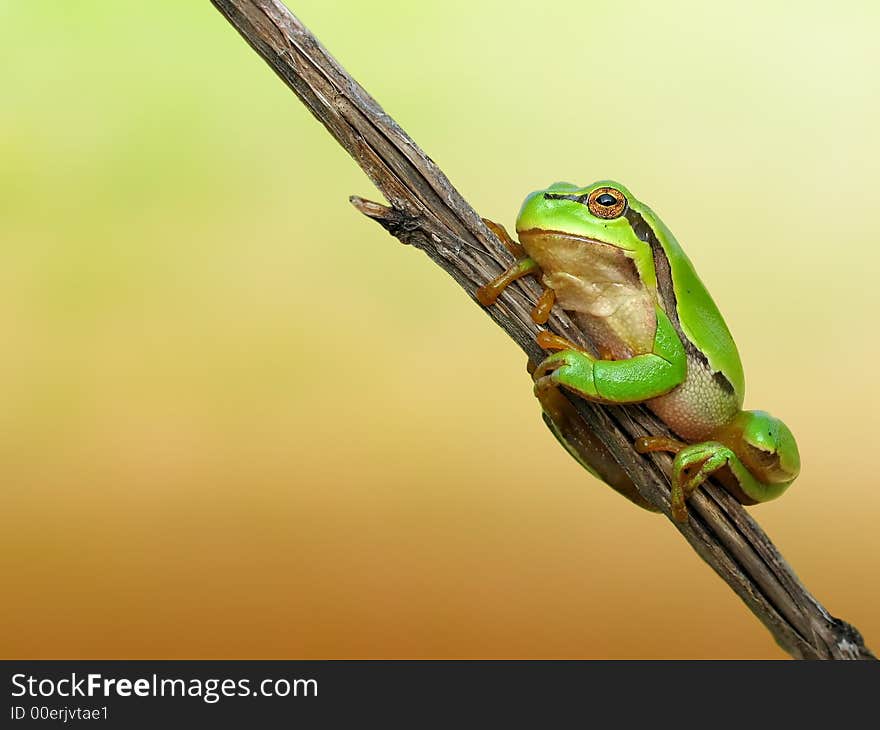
xmin=516 ymin=180 xmax=656 ymax=294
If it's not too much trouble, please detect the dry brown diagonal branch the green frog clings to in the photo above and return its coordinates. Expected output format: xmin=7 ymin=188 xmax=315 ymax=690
xmin=211 ymin=0 xmax=874 ymax=659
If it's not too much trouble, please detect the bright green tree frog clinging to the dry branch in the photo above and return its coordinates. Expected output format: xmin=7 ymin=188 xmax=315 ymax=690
xmin=477 ymin=180 xmax=800 ymax=521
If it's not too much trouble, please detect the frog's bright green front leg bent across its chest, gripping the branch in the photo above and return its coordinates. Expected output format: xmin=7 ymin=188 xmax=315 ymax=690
xmin=533 ymin=307 xmax=687 ymax=403
